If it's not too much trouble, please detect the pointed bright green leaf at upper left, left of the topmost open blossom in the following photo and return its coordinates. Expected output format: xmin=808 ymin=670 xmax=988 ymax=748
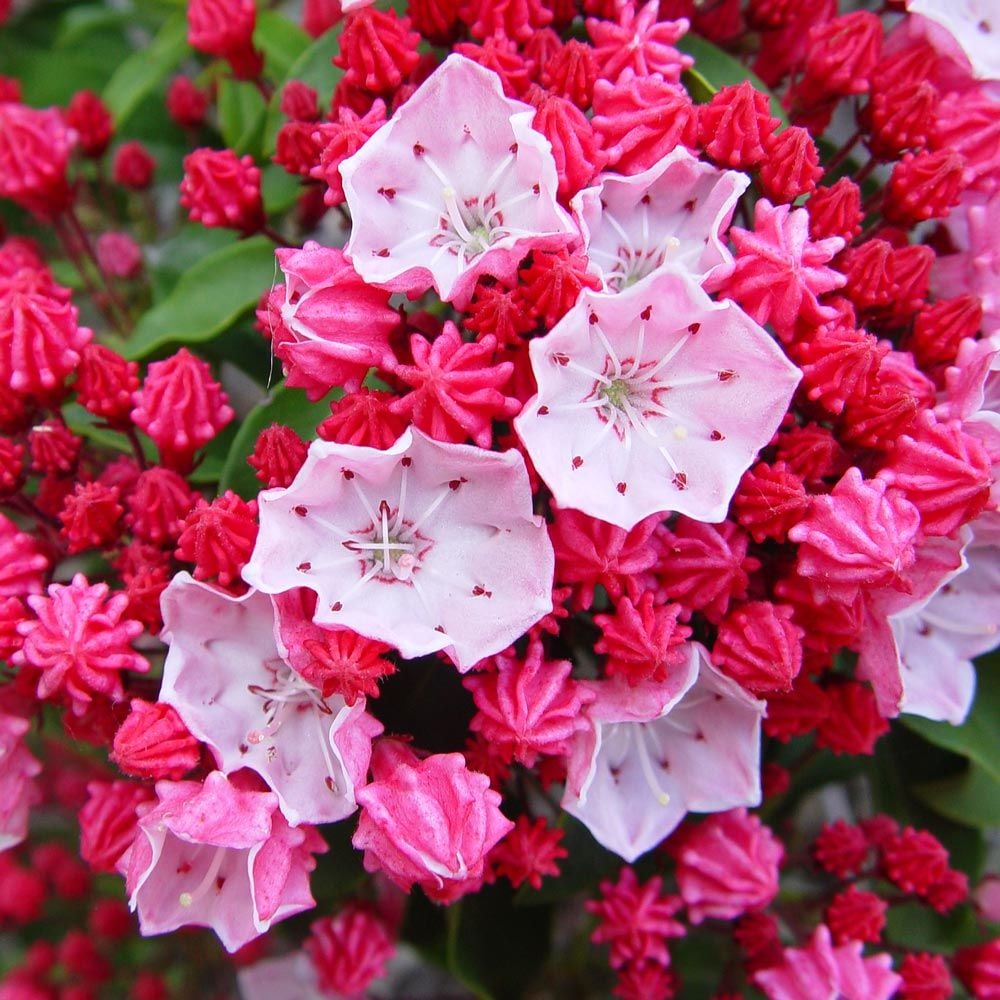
xmin=125 ymin=236 xmax=275 ymax=359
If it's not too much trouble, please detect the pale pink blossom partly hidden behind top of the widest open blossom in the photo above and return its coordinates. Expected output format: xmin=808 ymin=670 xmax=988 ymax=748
xmin=572 ymin=146 xmax=750 ymax=292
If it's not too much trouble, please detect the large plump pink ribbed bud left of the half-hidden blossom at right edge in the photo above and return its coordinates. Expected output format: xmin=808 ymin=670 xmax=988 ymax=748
xmin=788 ymin=466 xmax=920 ymax=603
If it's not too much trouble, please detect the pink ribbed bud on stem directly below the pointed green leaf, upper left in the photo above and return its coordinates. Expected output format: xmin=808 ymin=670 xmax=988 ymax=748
xmin=132 ymin=347 xmax=235 ymax=472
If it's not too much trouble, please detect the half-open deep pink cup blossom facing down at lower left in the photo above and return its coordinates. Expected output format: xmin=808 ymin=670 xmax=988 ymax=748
xmin=118 ymin=771 xmax=326 ymax=952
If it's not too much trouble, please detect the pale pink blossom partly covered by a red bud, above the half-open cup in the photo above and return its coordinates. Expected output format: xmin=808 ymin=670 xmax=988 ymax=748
xmin=160 ymin=573 xmax=382 ymax=824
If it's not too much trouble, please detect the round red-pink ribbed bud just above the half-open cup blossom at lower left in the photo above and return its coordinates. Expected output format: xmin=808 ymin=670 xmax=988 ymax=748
xmin=111 ymin=698 xmax=201 ymax=781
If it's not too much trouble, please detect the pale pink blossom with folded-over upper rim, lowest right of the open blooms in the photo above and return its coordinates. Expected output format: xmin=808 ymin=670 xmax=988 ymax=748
xmin=562 ymin=643 xmax=764 ymax=862
